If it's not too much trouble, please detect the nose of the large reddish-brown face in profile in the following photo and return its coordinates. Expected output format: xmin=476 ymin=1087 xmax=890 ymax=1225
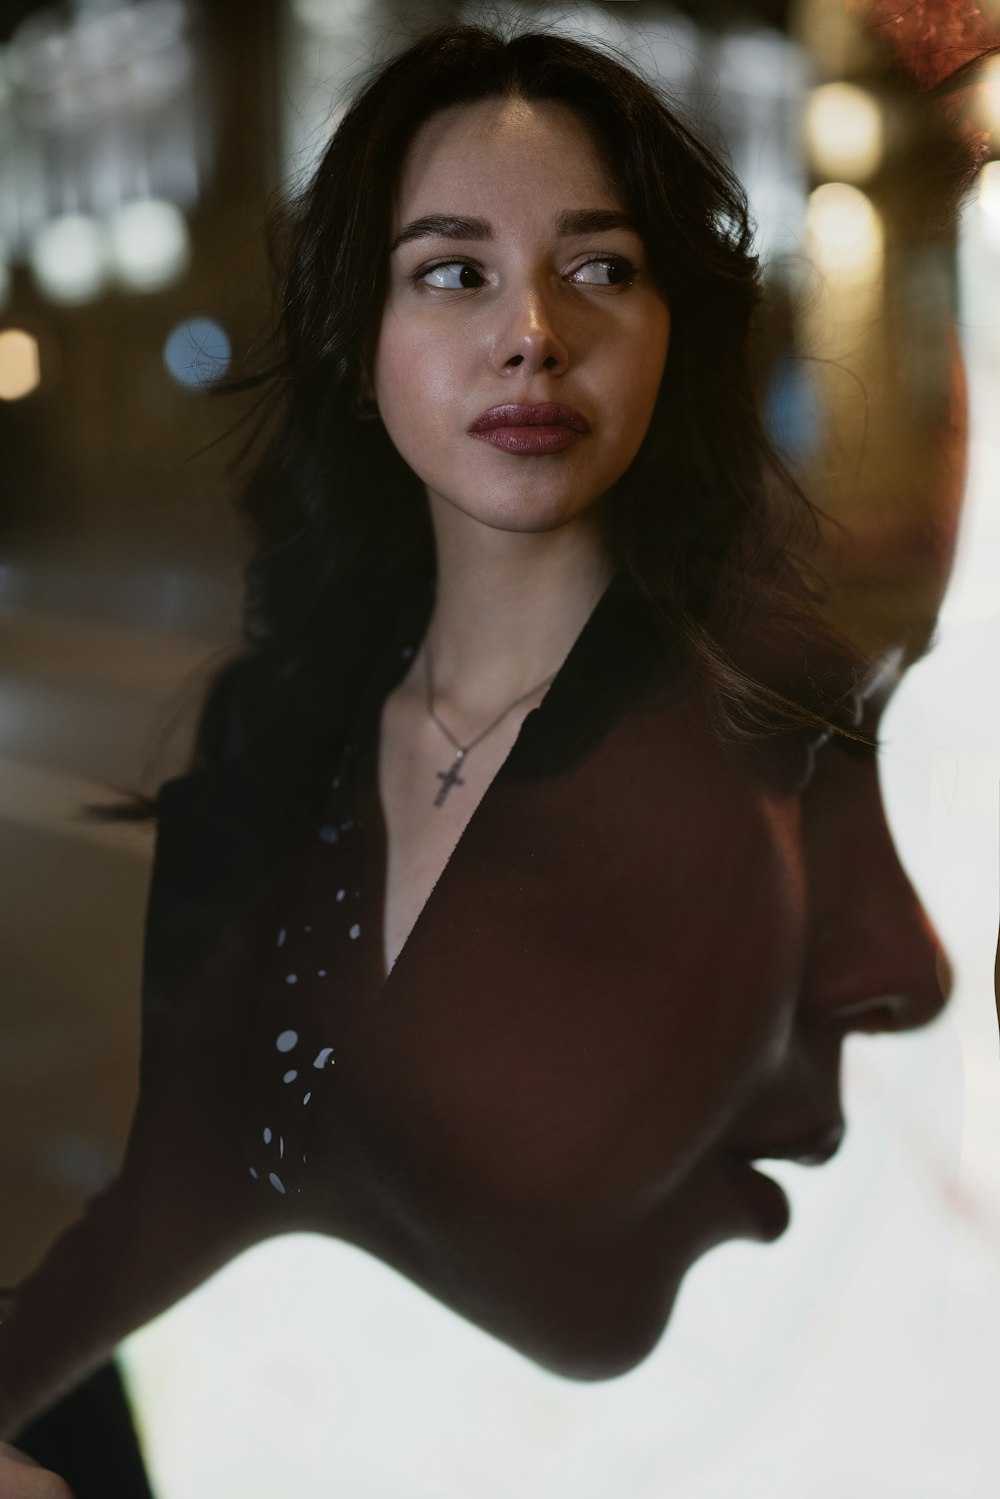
xmin=802 ymin=751 xmax=952 ymax=1031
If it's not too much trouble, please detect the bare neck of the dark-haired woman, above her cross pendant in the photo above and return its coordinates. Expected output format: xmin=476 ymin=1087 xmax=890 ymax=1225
xmin=414 ymin=507 xmax=613 ymax=720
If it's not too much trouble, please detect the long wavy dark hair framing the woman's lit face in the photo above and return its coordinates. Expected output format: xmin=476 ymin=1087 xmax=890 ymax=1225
xmin=195 ymin=17 xmax=851 ymax=809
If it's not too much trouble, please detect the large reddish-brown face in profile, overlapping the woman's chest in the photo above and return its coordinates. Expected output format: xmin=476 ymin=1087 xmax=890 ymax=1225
xmin=329 ymin=659 xmax=943 ymax=1378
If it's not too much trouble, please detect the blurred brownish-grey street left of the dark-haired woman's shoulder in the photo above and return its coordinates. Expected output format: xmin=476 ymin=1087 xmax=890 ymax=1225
xmin=0 ymin=559 xmax=238 ymax=1283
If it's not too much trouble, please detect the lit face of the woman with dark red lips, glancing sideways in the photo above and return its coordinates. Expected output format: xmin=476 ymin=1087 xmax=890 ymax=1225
xmin=372 ymin=99 xmax=670 ymax=532
